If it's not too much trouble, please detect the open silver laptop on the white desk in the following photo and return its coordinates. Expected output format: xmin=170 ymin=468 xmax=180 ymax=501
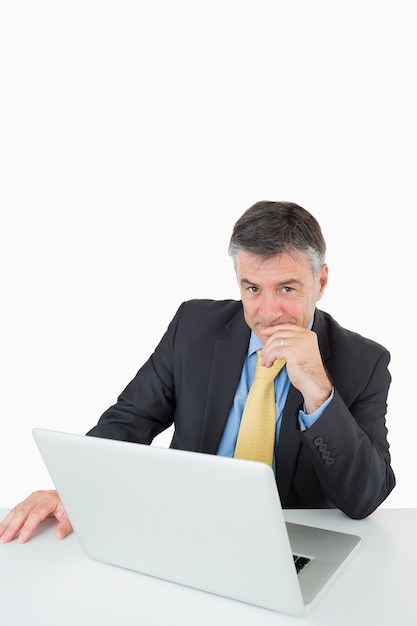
xmin=33 ymin=428 xmax=361 ymax=615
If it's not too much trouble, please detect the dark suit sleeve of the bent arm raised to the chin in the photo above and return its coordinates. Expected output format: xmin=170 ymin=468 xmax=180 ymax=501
xmin=301 ymin=350 xmax=395 ymax=519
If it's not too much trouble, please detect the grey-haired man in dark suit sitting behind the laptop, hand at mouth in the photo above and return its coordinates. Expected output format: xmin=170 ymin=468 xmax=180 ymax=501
xmin=0 ymin=202 xmax=395 ymax=543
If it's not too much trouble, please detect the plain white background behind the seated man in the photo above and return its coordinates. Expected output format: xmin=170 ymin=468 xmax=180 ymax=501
xmin=0 ymin=0 xmax=417 ymax=507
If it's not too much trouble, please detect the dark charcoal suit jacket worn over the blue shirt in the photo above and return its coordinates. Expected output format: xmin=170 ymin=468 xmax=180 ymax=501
xmin=88 ymin=300 xmax=395 ymax=518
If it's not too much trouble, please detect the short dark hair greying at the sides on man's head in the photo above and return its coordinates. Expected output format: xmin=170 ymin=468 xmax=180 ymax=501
xmin=229 ymin=200 xmax=326 ymax=277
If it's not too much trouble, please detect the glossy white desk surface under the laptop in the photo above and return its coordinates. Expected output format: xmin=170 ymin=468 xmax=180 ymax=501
xmin=0 ymin=509 xmax=417 ymax=626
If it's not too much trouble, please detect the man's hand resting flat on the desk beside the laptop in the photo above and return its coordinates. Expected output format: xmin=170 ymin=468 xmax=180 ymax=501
xmin=0 ymin=491 xmax=72 ymax=543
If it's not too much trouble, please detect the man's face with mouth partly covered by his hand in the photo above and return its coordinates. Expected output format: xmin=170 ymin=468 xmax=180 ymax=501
xmin=236 ymin=251 xmax=328 ymax=344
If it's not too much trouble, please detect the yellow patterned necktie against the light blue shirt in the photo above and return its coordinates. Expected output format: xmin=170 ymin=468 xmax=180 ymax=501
xmin=235 ymin=350 xmax=285 ymax=466
